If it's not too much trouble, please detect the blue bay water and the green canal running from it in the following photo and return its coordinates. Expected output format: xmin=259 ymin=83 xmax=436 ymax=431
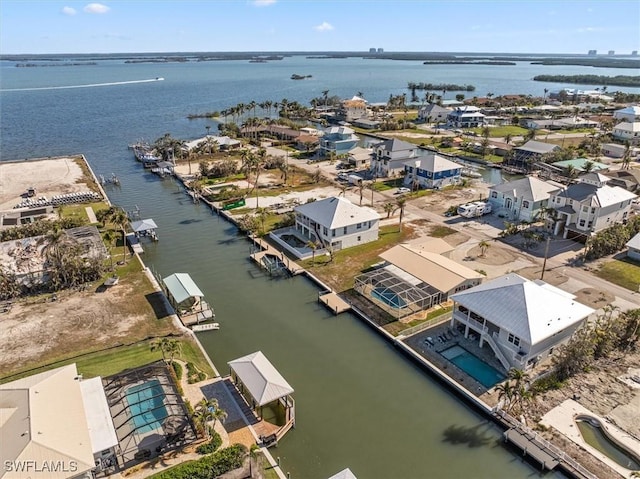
xmin=0 ymin=55 xmax=592 ymax=479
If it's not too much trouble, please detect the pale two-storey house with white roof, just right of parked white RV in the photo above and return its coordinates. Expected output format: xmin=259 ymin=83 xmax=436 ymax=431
xmin=488 ymin=176 xmax=560 ymax=221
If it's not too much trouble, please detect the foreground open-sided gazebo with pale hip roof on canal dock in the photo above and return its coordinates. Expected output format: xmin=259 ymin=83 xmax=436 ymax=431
xmin=228 ymin=351 xmax=295 ymax=439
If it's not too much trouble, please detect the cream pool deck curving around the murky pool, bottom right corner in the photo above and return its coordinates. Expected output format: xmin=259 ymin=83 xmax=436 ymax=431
xmin=540 ymin=399 xmax=640 ymax=478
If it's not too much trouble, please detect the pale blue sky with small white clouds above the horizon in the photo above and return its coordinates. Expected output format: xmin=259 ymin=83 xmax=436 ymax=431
xmin=0 ymin=0 xmax=640 ymax=54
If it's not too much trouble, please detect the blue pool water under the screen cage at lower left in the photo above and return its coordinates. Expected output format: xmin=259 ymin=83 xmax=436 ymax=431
xmin=126 ymin=379 xmax=168 ymax=433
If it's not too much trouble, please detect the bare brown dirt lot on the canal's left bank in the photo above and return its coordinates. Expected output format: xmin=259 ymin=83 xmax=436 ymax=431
xmin=0 ymin=272 xmax=174 ymax=376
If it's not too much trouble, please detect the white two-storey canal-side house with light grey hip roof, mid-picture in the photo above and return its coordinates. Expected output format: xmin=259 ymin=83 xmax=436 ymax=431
xmin=294 ymin=196 xmax=380 ymax=251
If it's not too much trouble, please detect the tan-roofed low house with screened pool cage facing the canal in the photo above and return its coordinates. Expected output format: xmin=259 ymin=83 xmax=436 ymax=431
xmin=354 ymin=244 xmax=484 ymax=319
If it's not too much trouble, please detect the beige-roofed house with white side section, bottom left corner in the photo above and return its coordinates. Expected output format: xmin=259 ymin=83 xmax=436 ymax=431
xmin=0 ymin=363 xmax=118 ymax=479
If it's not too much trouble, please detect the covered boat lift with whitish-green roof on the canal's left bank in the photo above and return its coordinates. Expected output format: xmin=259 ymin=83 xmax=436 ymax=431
xmin=162 ymin=273 xmax=215 ymax=326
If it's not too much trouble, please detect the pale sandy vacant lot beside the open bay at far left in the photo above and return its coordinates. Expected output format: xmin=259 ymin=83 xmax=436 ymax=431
xmin=0 ymin=157 xmax=96 ymax=211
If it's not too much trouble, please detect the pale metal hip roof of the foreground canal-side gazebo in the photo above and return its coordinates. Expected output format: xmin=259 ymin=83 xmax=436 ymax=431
xmin=228 ymin=351 xmax=293 ymax=406
